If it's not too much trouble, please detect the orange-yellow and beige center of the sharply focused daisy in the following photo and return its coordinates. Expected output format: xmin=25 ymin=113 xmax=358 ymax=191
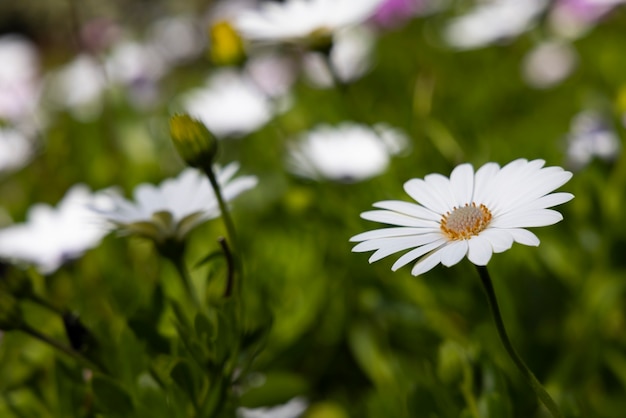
xmin=441 ymin=202 xmax=491 ymax=241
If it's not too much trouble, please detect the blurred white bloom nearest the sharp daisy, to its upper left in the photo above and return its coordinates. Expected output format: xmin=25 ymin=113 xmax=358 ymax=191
xmin=287 ymin=122 xmax=408 ymax=182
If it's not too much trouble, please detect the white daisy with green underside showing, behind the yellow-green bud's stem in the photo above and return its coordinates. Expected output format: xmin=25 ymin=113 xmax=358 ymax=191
xmin=94 ymin=163 xmax=257 ymax=243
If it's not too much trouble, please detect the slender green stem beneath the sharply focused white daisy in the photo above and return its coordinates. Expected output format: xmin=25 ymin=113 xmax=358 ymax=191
xmin=476 ymin=266 xmax=563 ymax=418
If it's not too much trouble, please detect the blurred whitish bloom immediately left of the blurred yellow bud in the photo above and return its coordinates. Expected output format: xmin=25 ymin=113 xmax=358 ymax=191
xmin=150 ymin=16 xmax=206 ymax=65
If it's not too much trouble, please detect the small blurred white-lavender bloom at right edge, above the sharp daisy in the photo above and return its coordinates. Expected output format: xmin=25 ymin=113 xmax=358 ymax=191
xmin=567 ymin=110 xmax=621 ymax=169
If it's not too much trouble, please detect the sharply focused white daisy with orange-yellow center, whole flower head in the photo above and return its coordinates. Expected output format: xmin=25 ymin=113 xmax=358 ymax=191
xmin=350 ymin=159 xmax=574 ymax=276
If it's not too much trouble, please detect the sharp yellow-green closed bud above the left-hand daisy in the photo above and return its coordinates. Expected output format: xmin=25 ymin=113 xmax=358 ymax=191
xmin=170 ymin=115 xmax=217 ymax=168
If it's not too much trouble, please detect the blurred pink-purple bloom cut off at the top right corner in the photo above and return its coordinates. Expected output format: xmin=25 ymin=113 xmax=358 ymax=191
xmin=548 ymin=0 xmax=626 ymax=39
